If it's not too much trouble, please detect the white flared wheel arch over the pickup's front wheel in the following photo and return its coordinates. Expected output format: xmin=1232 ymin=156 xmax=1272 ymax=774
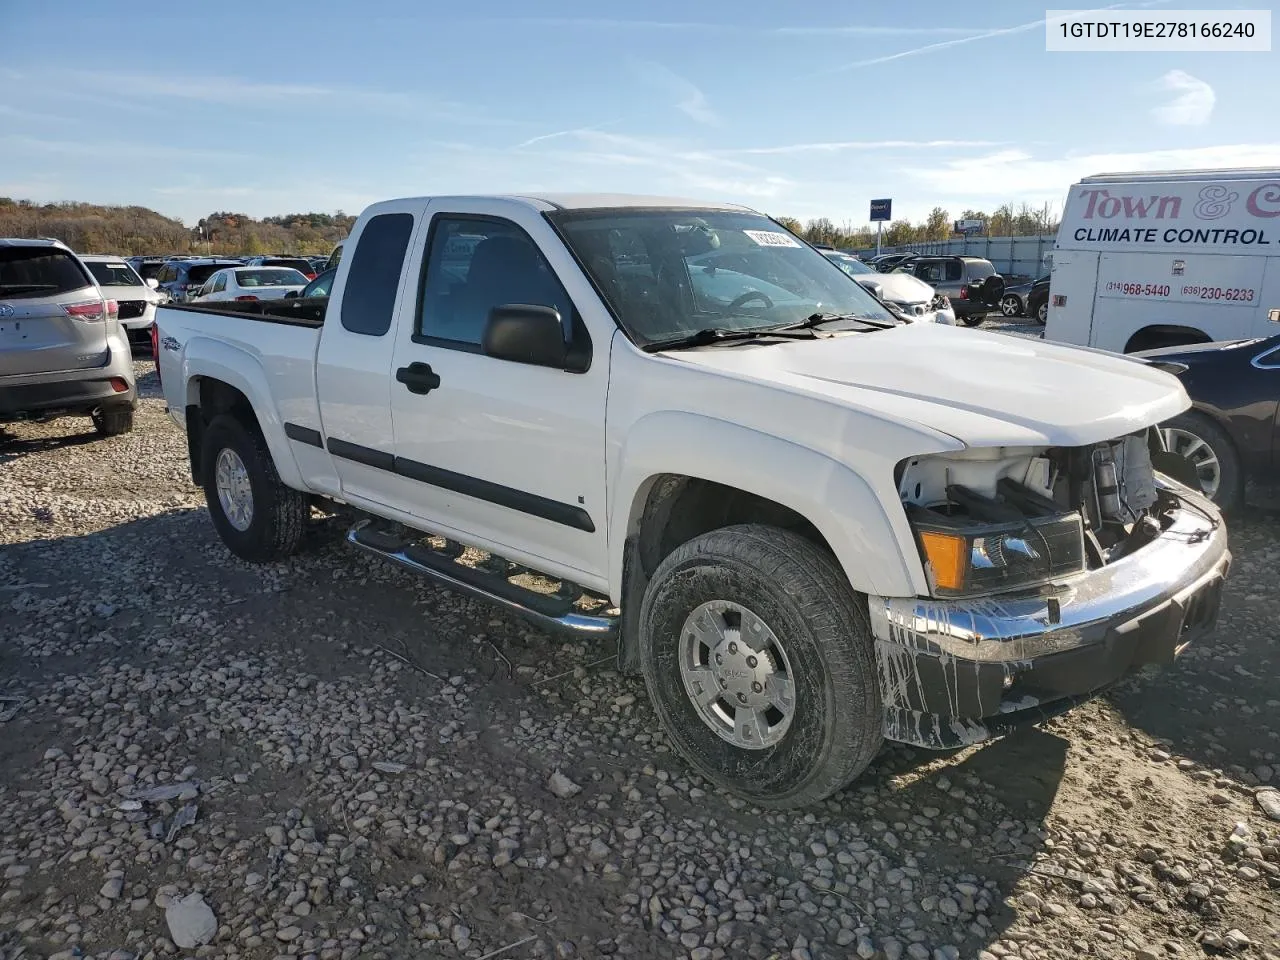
xmin=609 ymin=411 xmax=928 ymax=598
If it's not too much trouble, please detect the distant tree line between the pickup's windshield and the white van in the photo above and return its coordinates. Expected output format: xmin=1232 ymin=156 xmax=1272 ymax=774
xmin=774 ymin=204 xmax=1059 ymax=250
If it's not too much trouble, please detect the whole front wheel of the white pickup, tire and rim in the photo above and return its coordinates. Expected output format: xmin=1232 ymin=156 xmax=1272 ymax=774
xmin=640 ymin=525 xmax=882 ymax=809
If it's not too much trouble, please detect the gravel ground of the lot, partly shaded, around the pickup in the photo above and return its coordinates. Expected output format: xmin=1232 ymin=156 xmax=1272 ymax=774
xmin=0 ymin=355 xmax=1280 ymax=960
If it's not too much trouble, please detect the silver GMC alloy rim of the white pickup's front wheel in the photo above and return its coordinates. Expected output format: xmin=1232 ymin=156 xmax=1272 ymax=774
xmin=680 ymin=600 xmax=796 ymax=750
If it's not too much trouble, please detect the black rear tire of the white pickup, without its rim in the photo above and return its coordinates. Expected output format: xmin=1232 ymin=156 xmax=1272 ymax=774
xmin=200 ymin=415 xmax=311 ymax=563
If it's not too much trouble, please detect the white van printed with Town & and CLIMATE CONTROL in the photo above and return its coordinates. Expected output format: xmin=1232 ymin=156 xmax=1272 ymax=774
xmin=1044 ymin=169 xmax=1280 ymax=353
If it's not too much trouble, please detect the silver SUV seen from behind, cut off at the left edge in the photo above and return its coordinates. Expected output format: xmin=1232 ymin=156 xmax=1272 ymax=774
xmin=0 ymin=238 xmax=137 ymax=436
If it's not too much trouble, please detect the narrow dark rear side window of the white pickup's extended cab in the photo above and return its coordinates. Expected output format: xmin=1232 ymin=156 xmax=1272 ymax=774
xmin=340 ymin=214 xmax=413 ymax=337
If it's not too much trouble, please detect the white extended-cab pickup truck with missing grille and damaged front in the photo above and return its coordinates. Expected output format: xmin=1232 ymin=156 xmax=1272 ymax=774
xmin=156 ymin=196 xmax=1230 ymax=808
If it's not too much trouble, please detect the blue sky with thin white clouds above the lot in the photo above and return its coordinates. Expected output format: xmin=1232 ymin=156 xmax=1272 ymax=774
xmin=0 ymin=0 xmax=1280 ymax=225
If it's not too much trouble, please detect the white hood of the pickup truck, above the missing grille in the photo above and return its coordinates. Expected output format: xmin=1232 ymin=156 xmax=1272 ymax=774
xmin=663 ymin=324 xmax=1190 ymax=447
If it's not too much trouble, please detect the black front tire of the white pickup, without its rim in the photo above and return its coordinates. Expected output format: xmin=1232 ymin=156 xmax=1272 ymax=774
xmin=640 ymin=525 xmax=883 ymax=809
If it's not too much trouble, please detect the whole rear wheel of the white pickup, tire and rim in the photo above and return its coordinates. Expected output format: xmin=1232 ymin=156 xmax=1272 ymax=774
xmin=201 ymin=415 xmax=311 ymax=563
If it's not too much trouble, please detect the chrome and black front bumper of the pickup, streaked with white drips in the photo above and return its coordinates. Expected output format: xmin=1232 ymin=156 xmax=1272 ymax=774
xmin=869 ymin=488 xmax=1231 ymax=749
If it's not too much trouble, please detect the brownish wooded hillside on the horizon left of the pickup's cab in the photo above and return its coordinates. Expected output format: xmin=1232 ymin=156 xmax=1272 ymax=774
xmin=0 ymin=197 xmax=356 ymax=256
